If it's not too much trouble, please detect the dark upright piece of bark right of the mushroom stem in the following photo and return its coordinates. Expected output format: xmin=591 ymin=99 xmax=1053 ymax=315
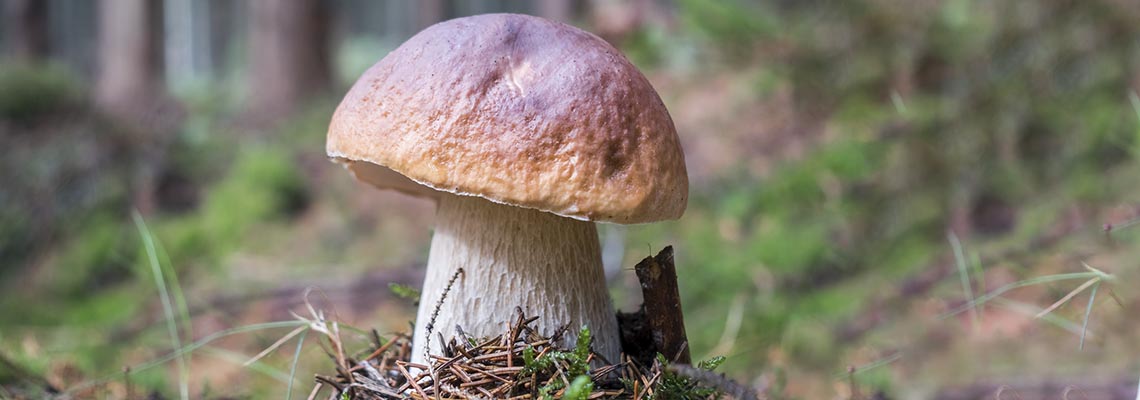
xmin=634 ymin=246 xmax=692 ymax=364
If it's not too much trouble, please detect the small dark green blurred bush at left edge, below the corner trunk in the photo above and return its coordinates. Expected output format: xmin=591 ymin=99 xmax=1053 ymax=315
xmin=0 ymin=65 xmax=82 ymax=122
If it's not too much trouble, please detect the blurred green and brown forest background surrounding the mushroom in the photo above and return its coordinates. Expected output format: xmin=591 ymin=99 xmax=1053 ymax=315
xmin=0 ymin=0 xmax=1140 ymax=399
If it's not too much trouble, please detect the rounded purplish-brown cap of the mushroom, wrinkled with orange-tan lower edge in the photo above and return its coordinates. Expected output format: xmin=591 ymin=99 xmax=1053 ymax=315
xmin=327 ymin=14 xmax=689 ymax=223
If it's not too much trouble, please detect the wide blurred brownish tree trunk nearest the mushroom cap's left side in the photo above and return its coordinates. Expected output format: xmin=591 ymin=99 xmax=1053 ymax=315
xmin=245 ymin=0 xmax=332 ymax=128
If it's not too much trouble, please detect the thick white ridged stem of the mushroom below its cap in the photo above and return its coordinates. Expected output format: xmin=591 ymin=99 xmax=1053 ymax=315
xmin=412 ymin=195 xmax=621 ymax=364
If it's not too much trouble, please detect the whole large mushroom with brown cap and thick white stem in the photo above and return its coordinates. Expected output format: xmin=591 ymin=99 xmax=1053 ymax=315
xmin=327 ymin=14 xmax=689 ymax=364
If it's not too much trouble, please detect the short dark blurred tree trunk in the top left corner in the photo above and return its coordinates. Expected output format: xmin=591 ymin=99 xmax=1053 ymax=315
xmin=2 ymin=0 xmax=48 ymax=63
